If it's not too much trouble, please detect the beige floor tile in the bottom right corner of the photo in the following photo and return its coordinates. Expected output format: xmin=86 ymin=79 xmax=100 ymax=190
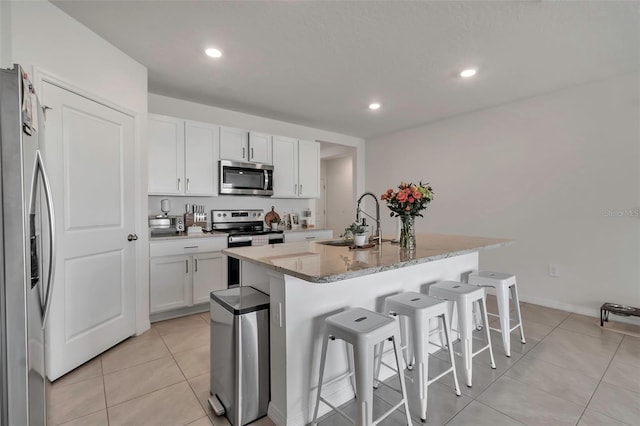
xmin=587 ymin=383 xmax=640 ymax=425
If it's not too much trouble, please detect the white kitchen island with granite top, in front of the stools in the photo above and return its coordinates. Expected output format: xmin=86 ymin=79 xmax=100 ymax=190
xmin=223 ymin=234 xmax=511 ymax=425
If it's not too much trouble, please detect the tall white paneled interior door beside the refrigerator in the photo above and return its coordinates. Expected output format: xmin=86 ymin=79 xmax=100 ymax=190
xmin=42 ymin=82 xmax=136 ymax=380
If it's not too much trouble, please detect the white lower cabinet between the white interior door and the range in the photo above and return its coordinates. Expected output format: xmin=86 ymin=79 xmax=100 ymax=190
xmin=149 ymin=237 xmax=227 ymax=314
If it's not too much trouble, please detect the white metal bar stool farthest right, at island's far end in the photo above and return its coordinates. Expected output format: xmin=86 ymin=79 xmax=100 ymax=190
xmin=468 ymin=271 xmax=526 ymax=356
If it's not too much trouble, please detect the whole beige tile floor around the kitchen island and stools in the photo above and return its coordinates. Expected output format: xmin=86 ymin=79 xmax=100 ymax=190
xmin=48 ymin=298 xmax=640 ymax=426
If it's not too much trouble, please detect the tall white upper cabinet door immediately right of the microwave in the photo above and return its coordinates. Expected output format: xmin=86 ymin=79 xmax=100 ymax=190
xmin=273 ymin=136 xmax=298 ymax=198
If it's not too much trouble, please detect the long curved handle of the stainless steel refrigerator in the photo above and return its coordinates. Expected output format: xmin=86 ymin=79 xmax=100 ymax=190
xmin=31 ymin=150 xmax=56 ymax=328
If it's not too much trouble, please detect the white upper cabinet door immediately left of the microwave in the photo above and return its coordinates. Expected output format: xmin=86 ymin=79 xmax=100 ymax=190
xmin=184 ymin=121 xmax=219 ymax=195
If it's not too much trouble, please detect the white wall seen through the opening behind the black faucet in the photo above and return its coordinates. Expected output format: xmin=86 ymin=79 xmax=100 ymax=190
xmin=322 ymin=156 xmax=356 ymax=238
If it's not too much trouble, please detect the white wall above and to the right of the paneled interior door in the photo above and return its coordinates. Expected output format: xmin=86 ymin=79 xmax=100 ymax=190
xmin=8 ymin=0 xmax=149 ymax=332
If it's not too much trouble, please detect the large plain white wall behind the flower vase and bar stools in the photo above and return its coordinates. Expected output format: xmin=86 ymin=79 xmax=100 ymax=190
xmin=366 ymin=74 xmax=640 ymax=319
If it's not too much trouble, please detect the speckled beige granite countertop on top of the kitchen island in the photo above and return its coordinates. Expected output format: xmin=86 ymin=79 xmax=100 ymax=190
xmin=222 ymin=234 xmax=513 ymax=283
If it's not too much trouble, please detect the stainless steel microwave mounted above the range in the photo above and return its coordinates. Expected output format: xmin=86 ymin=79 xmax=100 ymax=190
xmin=219 ymin=160 xmax=273 ymax=195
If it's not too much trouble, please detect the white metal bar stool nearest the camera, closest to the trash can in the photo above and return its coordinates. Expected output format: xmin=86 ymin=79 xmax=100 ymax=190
xmin=312 ymin=308 xmax=411 ymax=426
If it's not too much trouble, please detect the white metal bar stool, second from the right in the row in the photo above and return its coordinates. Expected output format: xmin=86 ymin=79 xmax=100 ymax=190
xmin=429 ymin=281 xmax=496 ymax=387
